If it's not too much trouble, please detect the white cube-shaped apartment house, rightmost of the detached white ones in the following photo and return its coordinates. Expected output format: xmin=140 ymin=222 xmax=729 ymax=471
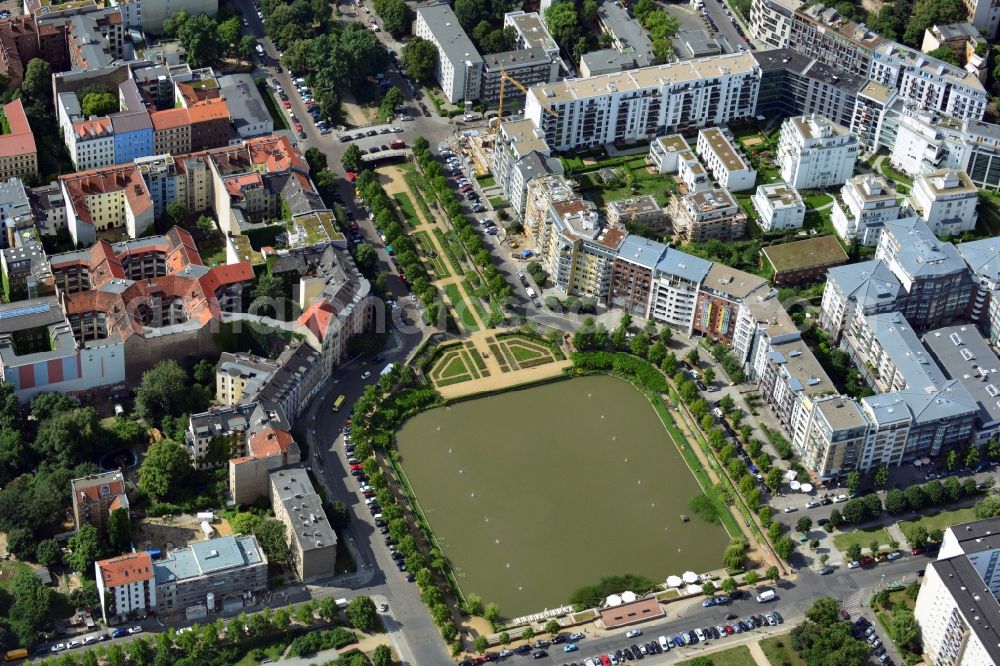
xmin=907 ymin=169 xmax=979 ymax=236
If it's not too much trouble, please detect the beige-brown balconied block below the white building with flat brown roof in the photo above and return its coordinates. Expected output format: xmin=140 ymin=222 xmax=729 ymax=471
xmin=668 ymin=189 xmax=747 ymax=243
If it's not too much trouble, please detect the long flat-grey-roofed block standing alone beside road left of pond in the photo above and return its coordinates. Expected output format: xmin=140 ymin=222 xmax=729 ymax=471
xmin=270 ymin=467 xmax=337 ymax=582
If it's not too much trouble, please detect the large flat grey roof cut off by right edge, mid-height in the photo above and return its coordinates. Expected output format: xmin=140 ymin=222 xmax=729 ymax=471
xmin=923 ymin=326 xmax=1000 ymax=424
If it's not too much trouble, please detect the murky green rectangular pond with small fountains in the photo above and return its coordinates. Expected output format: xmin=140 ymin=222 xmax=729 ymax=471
xmin=398 ymin=376 xmax=728 ymax=617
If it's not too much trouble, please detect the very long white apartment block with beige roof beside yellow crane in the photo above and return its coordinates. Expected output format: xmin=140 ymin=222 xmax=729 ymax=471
xmin=524 ymin=52 xmax=760 ymax=150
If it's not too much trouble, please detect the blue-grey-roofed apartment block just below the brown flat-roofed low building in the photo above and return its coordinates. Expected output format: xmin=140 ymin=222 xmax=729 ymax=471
xmin=819 ymin=259 xmax=906 ymax=343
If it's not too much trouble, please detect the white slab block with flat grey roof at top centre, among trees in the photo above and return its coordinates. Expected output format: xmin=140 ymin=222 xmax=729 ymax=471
xmin=413 ymin=4 xmax=483 ymax=104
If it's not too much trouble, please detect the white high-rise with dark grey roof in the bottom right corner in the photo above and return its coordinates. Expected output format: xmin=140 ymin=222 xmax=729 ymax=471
xmin=914 ymin=518 xmax=1000 ymax=666
